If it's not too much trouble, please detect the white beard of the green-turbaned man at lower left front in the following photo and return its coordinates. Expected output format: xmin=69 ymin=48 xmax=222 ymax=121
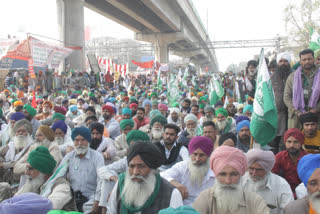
xmin=16 ymin=173 xmax=46 ymax=195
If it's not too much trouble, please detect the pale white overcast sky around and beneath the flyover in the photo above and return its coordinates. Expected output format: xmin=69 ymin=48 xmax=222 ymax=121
xmin=0 ymin=0 xmax=298 ymax=71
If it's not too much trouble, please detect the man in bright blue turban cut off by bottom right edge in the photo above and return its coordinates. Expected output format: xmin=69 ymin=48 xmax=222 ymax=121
xmin=284 ymin=154 xmax=320 ymax=214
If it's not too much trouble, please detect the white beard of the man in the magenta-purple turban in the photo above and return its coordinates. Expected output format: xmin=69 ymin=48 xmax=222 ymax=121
xmin=188 ymin=159 xmax=210 ymax=186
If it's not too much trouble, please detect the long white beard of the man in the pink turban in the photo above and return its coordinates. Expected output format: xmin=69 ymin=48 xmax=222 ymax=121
xmin=213 ymin=179 xmax=243 ymax=214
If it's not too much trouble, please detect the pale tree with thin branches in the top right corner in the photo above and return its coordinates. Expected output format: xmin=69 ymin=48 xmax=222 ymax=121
xmin=283 ymin=0 xmax=320 ymax=49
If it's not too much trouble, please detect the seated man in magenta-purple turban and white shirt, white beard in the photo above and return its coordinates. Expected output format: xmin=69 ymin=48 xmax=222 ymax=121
xmin=160 ymin=136 xmax=215 ymax=206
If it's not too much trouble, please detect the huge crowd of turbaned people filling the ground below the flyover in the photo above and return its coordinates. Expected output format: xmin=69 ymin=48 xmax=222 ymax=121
xmin=0 ymin=49 xmax=320 ymax=214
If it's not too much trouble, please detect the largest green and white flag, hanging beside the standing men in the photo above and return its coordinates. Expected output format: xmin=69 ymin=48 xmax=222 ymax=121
xmin=250 ymin=49 xmax=278 ymax=146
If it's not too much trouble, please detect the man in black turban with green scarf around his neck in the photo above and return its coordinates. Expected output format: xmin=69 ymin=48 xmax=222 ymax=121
xmin=107 ymin=142 xmax=183 ymax=213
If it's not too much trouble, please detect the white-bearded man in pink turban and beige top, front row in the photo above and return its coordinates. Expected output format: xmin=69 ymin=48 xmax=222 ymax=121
xmin=192 ymin=146 xmax=269 ymax=214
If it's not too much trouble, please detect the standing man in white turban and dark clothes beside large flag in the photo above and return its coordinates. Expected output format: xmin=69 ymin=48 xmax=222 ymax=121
xmin=269 ymin=52 xmax=292 ymax=154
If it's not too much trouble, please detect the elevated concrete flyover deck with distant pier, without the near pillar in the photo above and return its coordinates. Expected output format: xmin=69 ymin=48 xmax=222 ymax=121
xmin=57 ymin=0 xmax=218 ymax=71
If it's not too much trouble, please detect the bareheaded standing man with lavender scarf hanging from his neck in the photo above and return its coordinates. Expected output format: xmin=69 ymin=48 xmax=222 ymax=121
xmin=283 ymin=49 xmax=320 ymax=128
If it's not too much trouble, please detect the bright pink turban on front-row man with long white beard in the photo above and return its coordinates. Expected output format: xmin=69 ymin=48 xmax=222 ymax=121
xmin=210 ymin=146 xmax=248 ymax=176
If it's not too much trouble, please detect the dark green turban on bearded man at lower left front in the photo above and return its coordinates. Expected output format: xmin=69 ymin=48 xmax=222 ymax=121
xmin=28 ymin=146 xmax=57 ymax=175
